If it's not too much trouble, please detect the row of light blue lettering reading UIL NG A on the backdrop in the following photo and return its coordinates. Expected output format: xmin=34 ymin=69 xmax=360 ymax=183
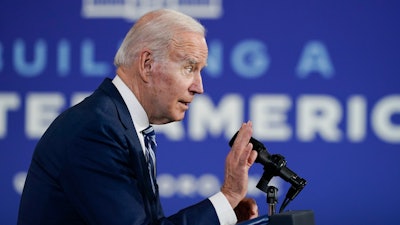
xmin=4 ymin=38 xmax=335 ymax=79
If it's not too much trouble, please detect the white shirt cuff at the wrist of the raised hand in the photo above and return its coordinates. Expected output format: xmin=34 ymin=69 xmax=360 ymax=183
xmin=209 ymin=192 xmax=237 ymax=225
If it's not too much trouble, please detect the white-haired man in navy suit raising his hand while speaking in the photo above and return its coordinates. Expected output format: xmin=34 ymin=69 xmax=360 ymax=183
xmin=18 ymin=10 xmax=258 ymax=225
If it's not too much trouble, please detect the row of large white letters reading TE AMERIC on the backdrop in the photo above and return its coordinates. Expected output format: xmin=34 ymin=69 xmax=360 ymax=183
xmin=0 ymin=92 xmax=400 ymax=143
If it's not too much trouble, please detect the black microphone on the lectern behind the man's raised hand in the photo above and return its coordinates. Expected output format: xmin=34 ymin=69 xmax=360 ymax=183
xmin=229 ymin=131 xmax=307 ymax=200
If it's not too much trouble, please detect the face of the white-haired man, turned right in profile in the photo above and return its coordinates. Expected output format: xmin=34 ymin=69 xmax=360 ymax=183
xmin=147 ymin=33 xmax=208 ymax=124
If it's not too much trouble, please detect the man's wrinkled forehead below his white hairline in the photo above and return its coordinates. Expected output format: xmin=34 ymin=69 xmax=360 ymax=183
xmin=169 ymin=33 xmax=208 ymax=65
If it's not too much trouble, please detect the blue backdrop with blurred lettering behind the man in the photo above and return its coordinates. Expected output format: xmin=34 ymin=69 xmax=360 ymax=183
xmin=0 ymin=0 xmax=400 ymax=225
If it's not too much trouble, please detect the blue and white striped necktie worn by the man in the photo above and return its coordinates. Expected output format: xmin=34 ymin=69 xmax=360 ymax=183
xmin=142 ymin=125 xmax=157 ymax=193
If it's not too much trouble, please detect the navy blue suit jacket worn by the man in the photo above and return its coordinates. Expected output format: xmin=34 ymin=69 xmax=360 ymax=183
xmin=18 ymin=78 xmax=219 ymax=225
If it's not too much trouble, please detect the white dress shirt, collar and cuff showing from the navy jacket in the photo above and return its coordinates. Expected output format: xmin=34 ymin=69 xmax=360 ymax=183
xmin=112 ymin=75 xmax=237 ymax=225
